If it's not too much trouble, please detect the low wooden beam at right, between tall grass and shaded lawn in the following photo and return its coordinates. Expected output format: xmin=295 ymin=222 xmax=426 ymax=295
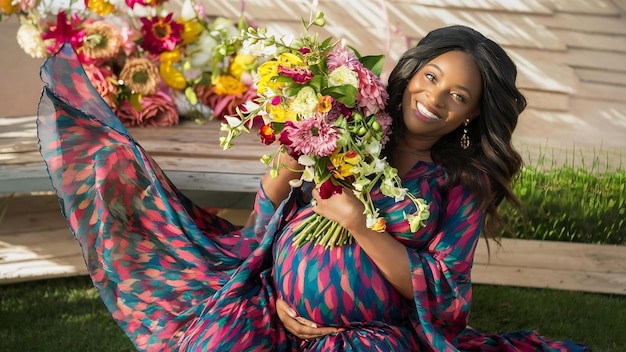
xmin=472 ymin=239 xmax=626 ymax=295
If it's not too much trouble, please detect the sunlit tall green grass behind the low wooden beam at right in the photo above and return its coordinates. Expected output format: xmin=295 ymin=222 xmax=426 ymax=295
xmin=501 ymin=148 xmax=626 ymax=245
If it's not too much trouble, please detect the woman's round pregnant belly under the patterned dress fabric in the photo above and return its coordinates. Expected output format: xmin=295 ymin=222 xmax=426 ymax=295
xmin=273 ymin=227 xmax=408 ymax=325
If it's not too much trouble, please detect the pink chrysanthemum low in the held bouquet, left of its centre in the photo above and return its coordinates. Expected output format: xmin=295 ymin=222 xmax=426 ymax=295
xmin=283 ymin=117 xmax=338 ymax=157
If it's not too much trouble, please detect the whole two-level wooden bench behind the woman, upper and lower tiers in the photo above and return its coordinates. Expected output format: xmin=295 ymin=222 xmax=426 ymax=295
xmin=0 ymin=117 xmax=626 ymax=295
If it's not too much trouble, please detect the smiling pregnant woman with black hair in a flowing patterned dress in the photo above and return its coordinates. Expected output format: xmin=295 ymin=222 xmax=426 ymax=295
xmin=38 ymin=18 xmax=586 ymax=352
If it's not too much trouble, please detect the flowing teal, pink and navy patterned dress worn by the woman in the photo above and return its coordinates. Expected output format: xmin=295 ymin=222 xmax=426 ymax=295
xmin=37 ymin=45 xmax=585 ymax=351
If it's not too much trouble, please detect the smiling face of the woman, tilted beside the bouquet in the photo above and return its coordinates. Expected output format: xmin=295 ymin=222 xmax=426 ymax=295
xmin=402 ymin=51 xmax=482 ymax=143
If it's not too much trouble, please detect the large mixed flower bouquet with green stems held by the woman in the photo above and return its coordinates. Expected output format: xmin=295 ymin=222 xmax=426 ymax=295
xmin=220 ymin=13 xmax=429 ymax=247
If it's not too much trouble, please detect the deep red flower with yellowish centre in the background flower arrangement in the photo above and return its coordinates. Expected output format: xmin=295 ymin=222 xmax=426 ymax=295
xmin=141 ymin=13 xmax=185 ymax=54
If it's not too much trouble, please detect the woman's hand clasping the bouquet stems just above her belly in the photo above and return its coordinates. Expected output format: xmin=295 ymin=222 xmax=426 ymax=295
xmin=311 ymin=188 xmax=365 ymax=229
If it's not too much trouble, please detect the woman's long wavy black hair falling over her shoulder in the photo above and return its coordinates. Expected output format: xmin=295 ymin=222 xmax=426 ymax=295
xmin=384 ymin=25 xmax=526 ymax=238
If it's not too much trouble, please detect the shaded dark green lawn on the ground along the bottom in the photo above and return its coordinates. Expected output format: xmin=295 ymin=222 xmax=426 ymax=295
xmin=0 ymin=277 xmax=626 ymax=352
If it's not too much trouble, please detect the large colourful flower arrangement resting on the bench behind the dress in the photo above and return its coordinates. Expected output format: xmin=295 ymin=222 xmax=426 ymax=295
xmin=0 ymin=0 xmax=256 ymax=126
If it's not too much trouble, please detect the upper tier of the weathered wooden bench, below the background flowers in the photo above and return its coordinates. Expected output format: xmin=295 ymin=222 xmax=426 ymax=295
xmin=0 ymin=117 xmax=266 ymax=208
